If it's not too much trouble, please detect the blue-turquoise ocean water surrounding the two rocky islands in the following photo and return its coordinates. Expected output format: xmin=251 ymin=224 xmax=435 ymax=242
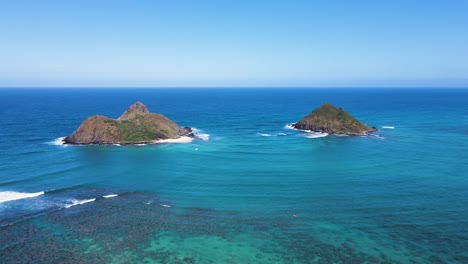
xmin=0 ymin=89 xmax=468 ymax=263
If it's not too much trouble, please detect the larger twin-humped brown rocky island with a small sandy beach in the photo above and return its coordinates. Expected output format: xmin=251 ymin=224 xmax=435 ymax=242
xmin=64 ymin=102 xmax=193 ymax=145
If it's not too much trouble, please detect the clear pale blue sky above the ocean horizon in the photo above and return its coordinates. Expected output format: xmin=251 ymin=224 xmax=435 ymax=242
xmin=0 ymin=0 xmax=468 ymax=87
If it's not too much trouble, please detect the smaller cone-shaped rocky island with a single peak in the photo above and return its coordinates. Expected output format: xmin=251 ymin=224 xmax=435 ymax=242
xmin=290 ymin=103 xmax=377 ymax=136
